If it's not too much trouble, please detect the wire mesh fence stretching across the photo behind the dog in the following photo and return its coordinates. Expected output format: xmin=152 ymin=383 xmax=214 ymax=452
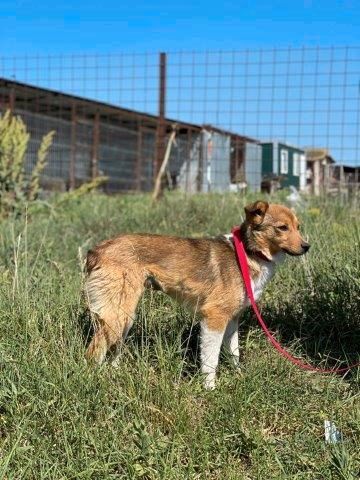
xmin=0 ymin=47 xmax=360 ymax=193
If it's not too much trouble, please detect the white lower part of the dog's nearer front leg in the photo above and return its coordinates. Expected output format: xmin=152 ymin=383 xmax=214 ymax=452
xmin=200 ymin=322 xmax=224 ymax=390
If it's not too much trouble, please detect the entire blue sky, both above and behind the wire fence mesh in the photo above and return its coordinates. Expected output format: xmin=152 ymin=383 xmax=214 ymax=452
xmin=0 ymin=0 xmax=360 ymax=164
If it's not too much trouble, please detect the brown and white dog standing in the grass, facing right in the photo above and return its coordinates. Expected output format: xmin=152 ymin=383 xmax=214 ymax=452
xmin=86 ymin=201 xmax=310 ymax=388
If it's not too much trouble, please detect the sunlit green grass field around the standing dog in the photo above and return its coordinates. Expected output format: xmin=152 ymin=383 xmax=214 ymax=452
xmin=0 ymin=194 xmax=360 ymax=480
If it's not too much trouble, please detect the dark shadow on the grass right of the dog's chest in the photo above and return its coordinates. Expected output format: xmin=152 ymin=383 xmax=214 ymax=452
xmin=241 ymin=285 xmax=360 ymax=376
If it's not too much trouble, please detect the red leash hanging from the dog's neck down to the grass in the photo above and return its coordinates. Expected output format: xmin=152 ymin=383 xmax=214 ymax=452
xmin=232 ymin=227 xmax=360 ymax=373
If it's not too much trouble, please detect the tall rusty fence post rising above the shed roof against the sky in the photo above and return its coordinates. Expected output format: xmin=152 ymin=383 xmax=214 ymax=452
xmin=154 ymin=52 xmax=166 ymax=181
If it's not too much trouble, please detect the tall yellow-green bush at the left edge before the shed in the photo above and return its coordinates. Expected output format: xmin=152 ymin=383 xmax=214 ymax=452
xmin=0 ymin=111 xmax=55 ymax=218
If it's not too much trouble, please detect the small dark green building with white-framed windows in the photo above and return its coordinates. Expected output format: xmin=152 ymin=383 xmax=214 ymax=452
xmin=261 ymin=141 xmax=306 ymax=191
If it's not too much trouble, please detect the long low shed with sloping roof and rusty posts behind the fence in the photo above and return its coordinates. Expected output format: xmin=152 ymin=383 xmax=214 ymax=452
xmin=0 ymin=78 xmax=261 ymax=192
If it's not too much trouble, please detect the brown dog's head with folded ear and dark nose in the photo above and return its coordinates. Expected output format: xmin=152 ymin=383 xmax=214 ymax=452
xmin=242 ymin=201 xmax=310 ymax=260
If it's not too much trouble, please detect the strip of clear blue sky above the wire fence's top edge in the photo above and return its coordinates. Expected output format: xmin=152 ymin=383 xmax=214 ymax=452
xmin=0 ymin=0 xmax=360 ymax=55
